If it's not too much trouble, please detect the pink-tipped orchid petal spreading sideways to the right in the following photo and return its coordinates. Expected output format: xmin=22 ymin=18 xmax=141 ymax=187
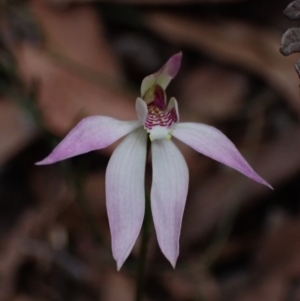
xmin=173 ymin=123 xmax=272 ymax=189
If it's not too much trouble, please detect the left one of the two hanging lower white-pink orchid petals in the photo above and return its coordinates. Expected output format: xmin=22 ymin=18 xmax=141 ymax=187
xmin=105 ymin=128 xmax=147 ymax=270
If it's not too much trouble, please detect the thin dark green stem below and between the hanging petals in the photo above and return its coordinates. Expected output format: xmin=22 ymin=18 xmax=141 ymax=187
xmin=135 ymin=196 xmax=151 ymax=301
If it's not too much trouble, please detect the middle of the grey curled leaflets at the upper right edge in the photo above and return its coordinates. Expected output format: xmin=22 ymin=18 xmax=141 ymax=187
xmin=280 ymin=28 xmax=300 ymax=55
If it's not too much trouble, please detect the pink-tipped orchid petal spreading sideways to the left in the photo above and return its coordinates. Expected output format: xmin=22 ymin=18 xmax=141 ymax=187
xmin=36 ymin=116 xmax=141 ymax=165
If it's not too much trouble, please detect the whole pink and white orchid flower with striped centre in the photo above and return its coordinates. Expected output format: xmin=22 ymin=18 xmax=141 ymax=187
xmin=37 ymin=53 xmax=271 ymax=269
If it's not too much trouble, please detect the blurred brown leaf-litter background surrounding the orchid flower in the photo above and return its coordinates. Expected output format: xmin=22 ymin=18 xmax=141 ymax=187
xmin=0 ymin=0 xmax=300 ymax=301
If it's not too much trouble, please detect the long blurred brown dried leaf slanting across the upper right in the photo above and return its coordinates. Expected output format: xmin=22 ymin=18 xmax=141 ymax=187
xmin=147 ymin=13 xmax=300 ymax=114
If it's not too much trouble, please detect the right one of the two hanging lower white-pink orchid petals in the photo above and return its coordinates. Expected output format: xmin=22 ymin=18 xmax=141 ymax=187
xmin=151 ymin=140 xmax=189 ymax=267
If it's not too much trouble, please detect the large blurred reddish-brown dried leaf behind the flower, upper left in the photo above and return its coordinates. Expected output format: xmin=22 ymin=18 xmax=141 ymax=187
xmin=16 ymin=1 xmax=136 ymax=135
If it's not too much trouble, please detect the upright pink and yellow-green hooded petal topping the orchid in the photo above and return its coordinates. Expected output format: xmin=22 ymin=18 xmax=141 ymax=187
xmin=141 ymin=52 xmax=182 ymax=96
